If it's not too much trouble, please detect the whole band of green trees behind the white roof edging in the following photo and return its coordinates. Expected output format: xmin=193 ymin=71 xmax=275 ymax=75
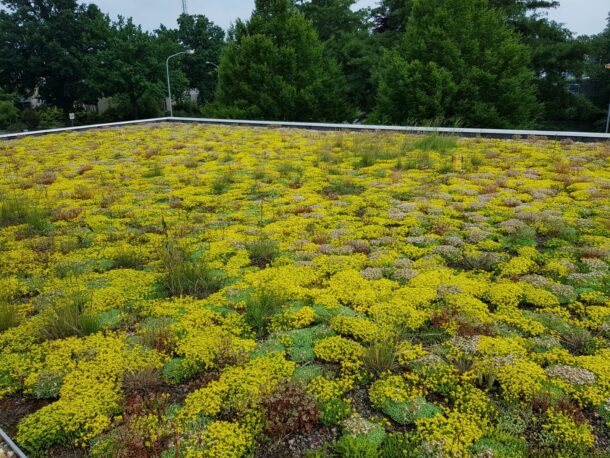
xmin=0 ymin=0 xmax=610 ymax=130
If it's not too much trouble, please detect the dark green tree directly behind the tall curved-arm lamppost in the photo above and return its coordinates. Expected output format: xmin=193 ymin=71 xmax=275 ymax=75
xmin=90 ymin=17 xmax=187 ymax=119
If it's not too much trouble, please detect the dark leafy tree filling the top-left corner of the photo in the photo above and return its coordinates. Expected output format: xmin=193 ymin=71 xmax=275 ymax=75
xmin=0 ymin=0 xmax=109 ymax=111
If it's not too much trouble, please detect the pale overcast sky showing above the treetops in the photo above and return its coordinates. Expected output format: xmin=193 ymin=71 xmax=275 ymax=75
xmin=89 ymin=0 xmax=610 ymax=35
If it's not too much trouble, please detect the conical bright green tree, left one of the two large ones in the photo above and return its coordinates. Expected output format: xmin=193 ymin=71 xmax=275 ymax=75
xmin=206 ymin=0 xmax=352 ymax=121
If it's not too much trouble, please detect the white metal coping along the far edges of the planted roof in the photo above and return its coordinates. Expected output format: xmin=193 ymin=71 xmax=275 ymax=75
xmin=0 ymin=117 xmax=610 ymax=142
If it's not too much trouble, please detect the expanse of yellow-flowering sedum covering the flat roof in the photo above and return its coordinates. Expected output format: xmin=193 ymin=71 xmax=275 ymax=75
xmin=0 ymin=124 xmax=610 ymax=457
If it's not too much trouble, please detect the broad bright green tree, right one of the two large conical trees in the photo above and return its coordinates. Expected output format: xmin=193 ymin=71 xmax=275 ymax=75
xmin=373 ymin=0 xmax=539 ymax=128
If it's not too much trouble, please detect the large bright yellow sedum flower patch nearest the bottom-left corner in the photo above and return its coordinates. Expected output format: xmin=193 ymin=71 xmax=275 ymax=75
xmin=17 ymin=334 xmax=162 ymax=451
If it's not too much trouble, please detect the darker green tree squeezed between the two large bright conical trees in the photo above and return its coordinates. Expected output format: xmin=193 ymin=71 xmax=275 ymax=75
xmin=298 ymin=0 xmax=380 ymax=113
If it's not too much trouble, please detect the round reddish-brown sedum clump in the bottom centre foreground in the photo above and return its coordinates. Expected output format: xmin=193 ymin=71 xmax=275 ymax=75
xmin=262 ymin=382 xmax=319 ymax=437
